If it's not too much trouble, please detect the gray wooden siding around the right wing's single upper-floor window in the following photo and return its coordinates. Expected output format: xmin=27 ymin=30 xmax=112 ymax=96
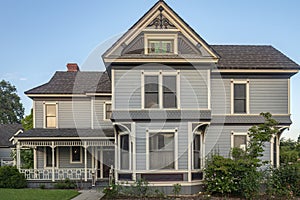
xmin=211 ymin=78 xmax=288 ymax=115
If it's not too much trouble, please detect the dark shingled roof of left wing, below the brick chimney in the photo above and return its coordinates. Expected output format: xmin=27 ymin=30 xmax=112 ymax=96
xmin=25 ymin=71 xmax=111 ymax=95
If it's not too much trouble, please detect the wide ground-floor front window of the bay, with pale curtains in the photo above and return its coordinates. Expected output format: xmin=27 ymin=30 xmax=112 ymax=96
xmin=149 ymin=133 xmax=175 ymax=169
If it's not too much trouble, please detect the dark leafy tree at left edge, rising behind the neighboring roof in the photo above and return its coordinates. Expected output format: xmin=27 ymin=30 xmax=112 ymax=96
xmin=0 ymin=80 xmax=24 ymax=124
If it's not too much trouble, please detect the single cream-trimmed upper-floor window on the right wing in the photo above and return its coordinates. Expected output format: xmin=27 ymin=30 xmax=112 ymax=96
xmin=231 ymin=81 xmax=249 ymax=114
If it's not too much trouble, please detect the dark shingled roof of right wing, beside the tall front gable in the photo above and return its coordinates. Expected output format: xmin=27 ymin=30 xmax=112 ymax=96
xmin=212 ymin=45 xmax=300 ymax=69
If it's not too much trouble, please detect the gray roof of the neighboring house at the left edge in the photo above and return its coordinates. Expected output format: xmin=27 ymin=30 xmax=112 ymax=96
xmin=0 ymin=124 xmax=22 ymax=147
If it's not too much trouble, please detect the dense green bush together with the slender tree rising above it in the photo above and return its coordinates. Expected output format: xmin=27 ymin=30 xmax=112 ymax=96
xmin=205 ymin=113 xmax=279 ymax=199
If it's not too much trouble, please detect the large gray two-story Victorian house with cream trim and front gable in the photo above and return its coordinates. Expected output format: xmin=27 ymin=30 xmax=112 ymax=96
xmin=14 ymin=1 xmax=299 ymax=193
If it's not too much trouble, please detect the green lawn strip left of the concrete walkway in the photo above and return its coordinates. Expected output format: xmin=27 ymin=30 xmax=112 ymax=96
xmin=0 ymin=188 xmax=79 ymax=200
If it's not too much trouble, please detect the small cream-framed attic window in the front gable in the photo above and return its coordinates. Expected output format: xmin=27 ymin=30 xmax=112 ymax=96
xmin=144 ymin=34 xmax=177 ymax=54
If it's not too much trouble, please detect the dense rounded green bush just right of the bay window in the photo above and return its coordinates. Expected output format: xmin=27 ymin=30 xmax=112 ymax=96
xmin=205 ymin=155 xmax=262 ymax=199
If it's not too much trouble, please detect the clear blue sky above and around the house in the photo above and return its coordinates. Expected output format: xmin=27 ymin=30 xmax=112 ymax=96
xmin=0 ymin=0 xmax=300 ymax=139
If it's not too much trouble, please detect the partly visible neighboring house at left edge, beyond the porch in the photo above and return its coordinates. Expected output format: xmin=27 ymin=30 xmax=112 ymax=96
xmin=0 ymin=124 xmax=22 ymax=166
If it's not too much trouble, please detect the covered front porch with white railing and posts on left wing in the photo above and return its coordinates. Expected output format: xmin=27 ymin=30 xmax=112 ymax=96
xmin=14 ymin=129 xmax=115 ymax=184
